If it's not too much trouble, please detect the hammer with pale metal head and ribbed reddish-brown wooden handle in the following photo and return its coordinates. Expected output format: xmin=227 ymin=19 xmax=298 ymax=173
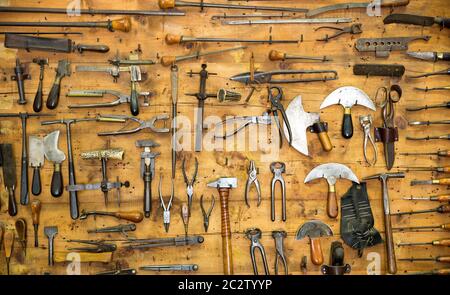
xmin=208 ymin=177 xmax=237 ymax=275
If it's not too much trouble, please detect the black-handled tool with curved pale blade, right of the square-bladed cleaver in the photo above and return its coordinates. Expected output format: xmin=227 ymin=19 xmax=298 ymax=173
xmin=44 ymin=130 xmax=66 ymax=197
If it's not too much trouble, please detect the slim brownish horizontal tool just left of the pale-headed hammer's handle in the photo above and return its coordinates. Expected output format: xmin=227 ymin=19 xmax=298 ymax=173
xmin=125 ymin=236 xmax=205 ymax=249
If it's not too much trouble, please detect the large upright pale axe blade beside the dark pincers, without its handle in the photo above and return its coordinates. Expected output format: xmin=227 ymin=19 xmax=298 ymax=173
xmin=284 ymin=95 xmax=320 ymax=156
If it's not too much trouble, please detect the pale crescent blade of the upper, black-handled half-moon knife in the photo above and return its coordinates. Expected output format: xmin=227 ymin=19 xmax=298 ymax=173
xmin=320 ymin=86 xmax=376 ymax=111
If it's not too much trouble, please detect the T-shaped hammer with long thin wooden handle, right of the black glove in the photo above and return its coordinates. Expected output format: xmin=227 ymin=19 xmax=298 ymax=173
xmin=363 ymin=172 xmax=405 ymax=274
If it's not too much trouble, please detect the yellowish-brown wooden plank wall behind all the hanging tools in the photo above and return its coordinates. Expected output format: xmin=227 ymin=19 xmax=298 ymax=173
xmin=0 ymin=0 xmax=450 ymax=274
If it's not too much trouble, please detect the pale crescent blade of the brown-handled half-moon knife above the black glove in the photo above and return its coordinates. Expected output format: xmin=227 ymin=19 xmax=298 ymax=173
xmin=305 ymin=163 xmax=359 ymax=185
